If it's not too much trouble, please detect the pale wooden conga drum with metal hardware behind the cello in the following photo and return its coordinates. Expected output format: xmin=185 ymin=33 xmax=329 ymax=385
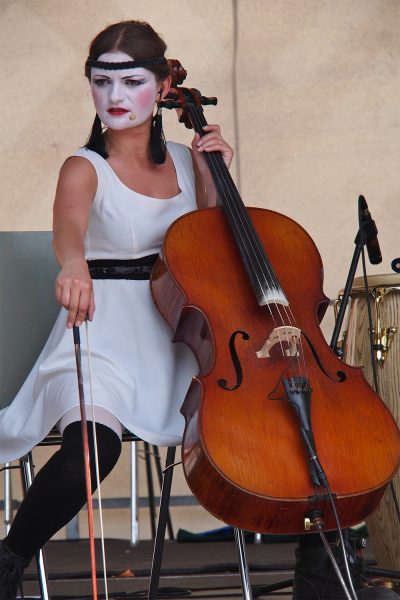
xmin=339 ymin=273 xmax=400 ymax=571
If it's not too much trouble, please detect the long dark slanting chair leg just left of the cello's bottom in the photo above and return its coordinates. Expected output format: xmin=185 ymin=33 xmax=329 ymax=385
xmin=148 ymin=446 xmax=176 ymax=600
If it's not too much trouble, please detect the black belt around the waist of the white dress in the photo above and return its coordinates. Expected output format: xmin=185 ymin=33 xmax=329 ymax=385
xmin=87 ymin=254 xmax=158 ymax=279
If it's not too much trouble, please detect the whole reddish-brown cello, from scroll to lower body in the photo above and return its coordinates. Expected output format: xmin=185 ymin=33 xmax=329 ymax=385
xmin=150 ymin=61 xmax=400 ymax=533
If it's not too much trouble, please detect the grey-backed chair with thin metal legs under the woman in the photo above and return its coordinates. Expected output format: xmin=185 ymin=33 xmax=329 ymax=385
xmin=0 ymin=231 xmax=252 ymax=600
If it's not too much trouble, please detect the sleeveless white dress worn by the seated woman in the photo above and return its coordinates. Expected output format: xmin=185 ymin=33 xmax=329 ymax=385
xmin=0 ymin=143 xmax=198 ymax=463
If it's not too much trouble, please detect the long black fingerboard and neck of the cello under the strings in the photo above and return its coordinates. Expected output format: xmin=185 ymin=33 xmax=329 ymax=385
xmin=186 ymin=103 xmax=288 ymax=306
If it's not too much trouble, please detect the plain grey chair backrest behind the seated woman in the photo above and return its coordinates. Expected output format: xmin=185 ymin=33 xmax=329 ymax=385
xmin=0 ymin=231 xmax=59 ymax=408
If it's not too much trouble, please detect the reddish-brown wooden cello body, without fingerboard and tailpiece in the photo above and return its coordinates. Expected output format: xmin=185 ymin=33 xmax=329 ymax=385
xmin=152 ymin=208 xmax=399 ymax=533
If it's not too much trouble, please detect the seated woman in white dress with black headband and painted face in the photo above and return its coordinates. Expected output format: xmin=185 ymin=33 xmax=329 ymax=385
xmin=0 ymin=21 xmax=233 ymax=600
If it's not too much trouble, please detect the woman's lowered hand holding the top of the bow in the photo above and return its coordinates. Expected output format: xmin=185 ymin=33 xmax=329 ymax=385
xmin=55 ymin=259 xmax=95 ymax=329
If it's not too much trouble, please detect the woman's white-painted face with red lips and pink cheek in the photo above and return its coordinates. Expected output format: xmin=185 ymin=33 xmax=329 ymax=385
xmin=90 ymin=52 xmax=160 ymax=129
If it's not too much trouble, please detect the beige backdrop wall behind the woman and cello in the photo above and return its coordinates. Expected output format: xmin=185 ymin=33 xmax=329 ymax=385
xmin=0 ymin=0 xmax=400 ymax=540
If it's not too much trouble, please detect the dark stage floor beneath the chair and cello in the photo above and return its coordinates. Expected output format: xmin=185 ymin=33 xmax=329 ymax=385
xmin=24 ymin=539 xmax=382 ymax=600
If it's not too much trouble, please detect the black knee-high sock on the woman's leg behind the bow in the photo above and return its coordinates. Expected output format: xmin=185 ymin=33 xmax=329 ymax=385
xmin=4 ymin=421 xmax=121 ymax=558
